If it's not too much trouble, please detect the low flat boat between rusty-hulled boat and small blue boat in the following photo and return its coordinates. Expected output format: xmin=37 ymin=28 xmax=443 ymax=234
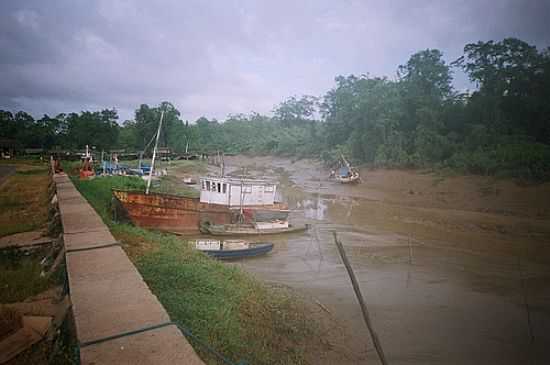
xmin=201 ymin=222 xmax=309 ymax=236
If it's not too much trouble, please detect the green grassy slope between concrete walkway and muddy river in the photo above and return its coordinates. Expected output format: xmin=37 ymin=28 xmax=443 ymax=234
xmin=70 ymin=163 xmax=326 ymax=364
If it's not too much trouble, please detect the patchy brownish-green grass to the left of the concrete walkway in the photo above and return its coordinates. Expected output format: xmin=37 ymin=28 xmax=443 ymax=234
xmin=0 ymin=161 xmax=78 ymax=365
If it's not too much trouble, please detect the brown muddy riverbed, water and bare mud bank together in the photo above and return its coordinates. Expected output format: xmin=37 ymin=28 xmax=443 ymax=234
xmin=192 ymin=156 xmax=550 ymax=364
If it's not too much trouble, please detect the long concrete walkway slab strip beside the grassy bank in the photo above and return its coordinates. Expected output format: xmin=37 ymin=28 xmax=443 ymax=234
xmin=54 ymin=174 xmax=204 ymax=365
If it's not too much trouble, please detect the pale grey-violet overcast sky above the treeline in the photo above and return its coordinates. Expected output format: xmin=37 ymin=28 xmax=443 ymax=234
xmin=0 ymin=0 xmax=550 ymax=120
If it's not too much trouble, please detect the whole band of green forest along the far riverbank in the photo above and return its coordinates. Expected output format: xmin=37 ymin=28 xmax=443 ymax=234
xmin=0 ymin=38 xmax=550 ymax=181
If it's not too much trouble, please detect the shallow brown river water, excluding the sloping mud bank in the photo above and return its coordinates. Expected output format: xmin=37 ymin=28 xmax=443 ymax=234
xmin=210 ymin=157 xmax=550 ymax=364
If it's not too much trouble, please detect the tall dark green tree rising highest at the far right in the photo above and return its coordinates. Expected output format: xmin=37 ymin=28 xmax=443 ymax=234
xmin=454 ymin=38 xmax=550 ymax=143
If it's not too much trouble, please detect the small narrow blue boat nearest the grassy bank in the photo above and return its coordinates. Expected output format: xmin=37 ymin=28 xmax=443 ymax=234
xmin=195 ymin=240 xmax=273 ymax=260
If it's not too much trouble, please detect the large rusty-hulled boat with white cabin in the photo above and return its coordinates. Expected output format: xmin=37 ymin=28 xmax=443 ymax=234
xmin=112 ymin=177 xmax=289 ymax=234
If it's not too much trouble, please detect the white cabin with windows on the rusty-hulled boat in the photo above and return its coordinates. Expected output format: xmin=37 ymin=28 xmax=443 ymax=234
xmin=200 ymin=177 xmax=277 ymax=208
